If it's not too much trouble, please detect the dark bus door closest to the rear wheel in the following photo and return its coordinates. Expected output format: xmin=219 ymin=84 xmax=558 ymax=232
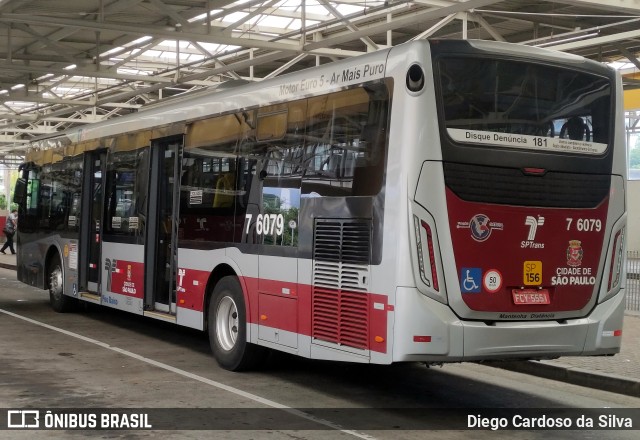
xmin=144 ymin=136 xmax=183 ymax=314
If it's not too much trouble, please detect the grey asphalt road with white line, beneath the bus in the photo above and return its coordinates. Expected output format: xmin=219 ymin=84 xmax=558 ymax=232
xmin=0 ymin=269 xmax=640 ymax=440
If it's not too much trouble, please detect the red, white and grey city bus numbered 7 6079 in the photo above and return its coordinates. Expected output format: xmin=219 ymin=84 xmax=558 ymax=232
xmin=15 ymin=40 xmax=627 ymax=370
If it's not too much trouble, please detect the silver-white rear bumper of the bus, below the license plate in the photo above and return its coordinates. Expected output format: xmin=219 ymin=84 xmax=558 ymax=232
xmin=393 ymin=288 xmax=624 ymax=362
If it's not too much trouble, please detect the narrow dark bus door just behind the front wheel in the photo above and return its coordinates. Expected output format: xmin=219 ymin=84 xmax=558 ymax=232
xmin=79 ymin=150 xmax=107 ymax=294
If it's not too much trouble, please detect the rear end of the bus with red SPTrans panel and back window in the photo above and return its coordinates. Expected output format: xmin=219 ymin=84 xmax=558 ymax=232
xmin=395 ymin=41 xmax=626 ymax=360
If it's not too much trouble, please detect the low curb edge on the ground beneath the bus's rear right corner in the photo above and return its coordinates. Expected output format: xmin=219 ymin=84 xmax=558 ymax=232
xmin=483 ymin=361 xmax=640 ymax=397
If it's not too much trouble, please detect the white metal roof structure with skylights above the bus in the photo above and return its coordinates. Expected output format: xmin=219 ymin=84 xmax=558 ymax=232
xmin=0 ymin=0 xmax=640 ymax=164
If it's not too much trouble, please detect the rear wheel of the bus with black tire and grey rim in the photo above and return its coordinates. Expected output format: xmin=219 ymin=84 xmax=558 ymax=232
xmin=207 ymin=276 xmax=268 ymax=371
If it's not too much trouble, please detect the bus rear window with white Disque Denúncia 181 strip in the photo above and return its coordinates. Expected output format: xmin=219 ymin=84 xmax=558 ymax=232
xmin=436 ymin=57 xmax=611 ymax=154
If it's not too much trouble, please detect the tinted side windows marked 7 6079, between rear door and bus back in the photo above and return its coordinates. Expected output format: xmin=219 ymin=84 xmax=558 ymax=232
xmin=180 ymin=82 xmax=389 ymax=248
